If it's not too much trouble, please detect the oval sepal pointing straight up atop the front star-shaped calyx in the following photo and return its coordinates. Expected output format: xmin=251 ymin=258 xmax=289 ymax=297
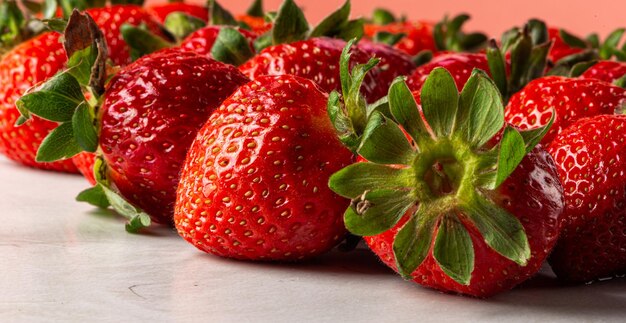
xmin=421 ymin=67 xmax=459 ymax=138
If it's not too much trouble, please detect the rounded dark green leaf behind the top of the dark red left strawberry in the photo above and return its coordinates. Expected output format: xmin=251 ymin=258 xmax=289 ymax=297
xmin=211 ymin=27 xmax=254 ymax=66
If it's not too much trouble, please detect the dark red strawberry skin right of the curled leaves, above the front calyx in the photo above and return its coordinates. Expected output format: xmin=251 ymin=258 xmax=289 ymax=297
xmin=357 ymin=40 xmax=416 ymax=97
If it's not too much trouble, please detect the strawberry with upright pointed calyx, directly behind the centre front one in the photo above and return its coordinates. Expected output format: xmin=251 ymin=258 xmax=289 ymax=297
xmin=240 ymin=0 xmax=382 ymax=102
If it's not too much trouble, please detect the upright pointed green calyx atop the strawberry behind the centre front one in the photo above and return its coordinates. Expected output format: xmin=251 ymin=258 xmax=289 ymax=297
xmin=255 ymin=0 xmax=364 ymax=50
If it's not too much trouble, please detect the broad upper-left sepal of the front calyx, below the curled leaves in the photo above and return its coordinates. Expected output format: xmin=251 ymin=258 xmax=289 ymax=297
xmin=358 ymin=113 xmax=417 ymax=165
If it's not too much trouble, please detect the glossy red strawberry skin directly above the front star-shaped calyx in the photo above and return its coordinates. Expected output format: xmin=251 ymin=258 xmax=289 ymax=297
xmin=407 ymin=53 xmax=490 ymax=91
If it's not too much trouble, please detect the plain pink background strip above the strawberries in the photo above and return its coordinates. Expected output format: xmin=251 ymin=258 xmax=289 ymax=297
xmin=171 ymin=0 xmax=626 ymax=36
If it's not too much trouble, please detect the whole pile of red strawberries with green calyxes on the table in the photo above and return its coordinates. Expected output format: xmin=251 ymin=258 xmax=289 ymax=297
xmin=0 ymin=0 xmax=626 ymax=297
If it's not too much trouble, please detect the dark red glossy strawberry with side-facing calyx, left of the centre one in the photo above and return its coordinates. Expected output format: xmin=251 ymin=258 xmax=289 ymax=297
xmin=20 ymin=12 xmax=248 ymax=229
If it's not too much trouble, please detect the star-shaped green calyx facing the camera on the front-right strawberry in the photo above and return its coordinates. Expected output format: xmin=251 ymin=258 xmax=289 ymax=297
xmin=329 ymin=49 xmax=551 ymax=285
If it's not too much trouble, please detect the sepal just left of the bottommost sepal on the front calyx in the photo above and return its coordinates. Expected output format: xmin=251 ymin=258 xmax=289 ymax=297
xmin=393 ymin=209 xmax=437 ymax=279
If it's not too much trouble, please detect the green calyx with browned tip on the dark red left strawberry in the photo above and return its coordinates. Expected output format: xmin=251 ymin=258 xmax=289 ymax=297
xmin=16 ymin=10 xmax=150 ymax=232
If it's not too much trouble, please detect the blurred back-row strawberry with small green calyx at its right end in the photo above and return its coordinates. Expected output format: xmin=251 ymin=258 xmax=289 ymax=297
xmin=365 ymin=9 xmax=487 ymax=56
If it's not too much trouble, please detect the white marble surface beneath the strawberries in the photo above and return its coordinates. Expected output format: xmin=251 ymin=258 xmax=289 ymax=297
xmin=0 ymin=159 xmax=626 ymax=322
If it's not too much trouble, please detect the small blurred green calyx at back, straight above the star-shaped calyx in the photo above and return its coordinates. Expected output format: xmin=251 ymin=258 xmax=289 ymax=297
xmin=433 ymin=14 xmax=487 ymax=52
